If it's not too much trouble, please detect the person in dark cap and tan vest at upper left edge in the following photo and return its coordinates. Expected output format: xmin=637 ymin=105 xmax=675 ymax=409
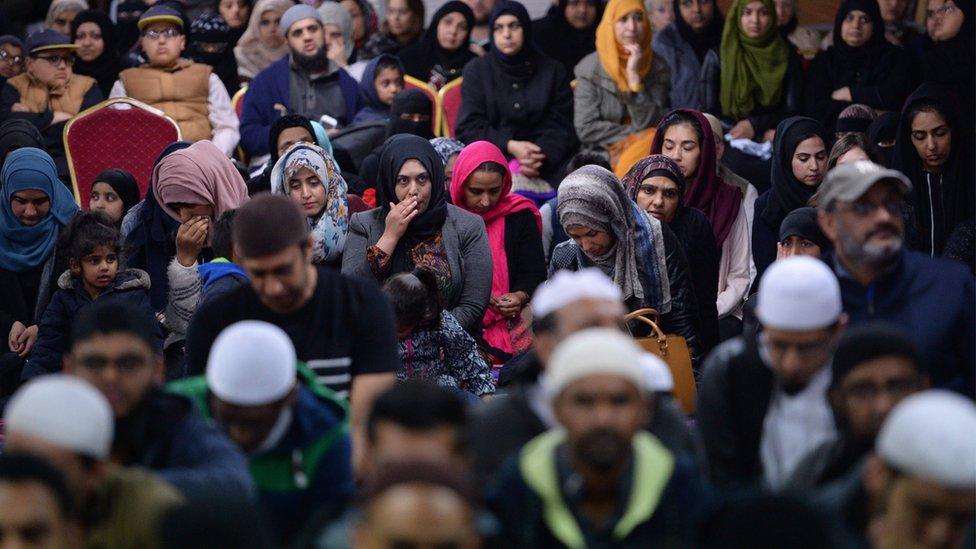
xmin=0 ymin=29 xmax=102 ymax=181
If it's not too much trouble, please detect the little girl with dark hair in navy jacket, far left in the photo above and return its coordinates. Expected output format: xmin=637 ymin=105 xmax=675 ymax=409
xmin=23 ymin=212 xmax=161 ymax=379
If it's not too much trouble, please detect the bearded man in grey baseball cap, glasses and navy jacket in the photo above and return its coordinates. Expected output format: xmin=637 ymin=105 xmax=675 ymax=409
xmin=818 ymin=161 xmax=976 ymax=395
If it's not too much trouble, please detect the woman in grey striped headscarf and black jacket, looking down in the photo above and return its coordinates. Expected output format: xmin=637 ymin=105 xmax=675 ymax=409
xmin=549 ymin=165 xmax=702 ymax=358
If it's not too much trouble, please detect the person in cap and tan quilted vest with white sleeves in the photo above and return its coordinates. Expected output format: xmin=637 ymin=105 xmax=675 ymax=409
xmin=109 ymin=6 xmax=240 ymax=156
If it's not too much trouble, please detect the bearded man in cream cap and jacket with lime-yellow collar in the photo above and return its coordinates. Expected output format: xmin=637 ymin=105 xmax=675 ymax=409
xmin=488 ymin=328 xmax=704 ymax=547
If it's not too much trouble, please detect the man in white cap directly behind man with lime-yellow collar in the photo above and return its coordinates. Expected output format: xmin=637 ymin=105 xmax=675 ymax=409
xmin=469 ymin=268 xmax=704 ymax=482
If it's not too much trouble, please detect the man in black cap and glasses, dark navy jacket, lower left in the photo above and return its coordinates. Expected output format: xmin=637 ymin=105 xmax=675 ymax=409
xmin=64 ymin=301 xmax=254 ymax=500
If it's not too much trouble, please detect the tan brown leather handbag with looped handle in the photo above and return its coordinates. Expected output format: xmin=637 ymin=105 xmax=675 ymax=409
xmin=624 ymin=309 xmax=698 ymax=415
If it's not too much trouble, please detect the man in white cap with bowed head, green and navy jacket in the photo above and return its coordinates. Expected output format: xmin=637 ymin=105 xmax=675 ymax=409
xmin=170 ymin=320 xmax=353 ymax=544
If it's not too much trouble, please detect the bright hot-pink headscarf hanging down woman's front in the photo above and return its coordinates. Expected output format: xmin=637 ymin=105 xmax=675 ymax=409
xmin=451 ymin=141 xmax=542 ymax=353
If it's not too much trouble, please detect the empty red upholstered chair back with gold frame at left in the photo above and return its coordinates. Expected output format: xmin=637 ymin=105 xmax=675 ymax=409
xmin=64 ymin=97 xmax=181 ymax=209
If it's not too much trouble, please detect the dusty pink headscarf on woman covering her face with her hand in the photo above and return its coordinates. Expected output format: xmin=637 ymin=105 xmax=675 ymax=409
xmin=150 ymin=141 xmax=247 ymax=221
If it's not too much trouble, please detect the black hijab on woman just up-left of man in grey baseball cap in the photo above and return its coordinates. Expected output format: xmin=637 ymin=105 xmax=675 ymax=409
xmin=760 ymin=116 xmax=830 ymax=230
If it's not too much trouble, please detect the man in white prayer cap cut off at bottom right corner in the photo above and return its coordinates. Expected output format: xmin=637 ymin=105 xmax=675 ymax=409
xmin=818 ymin=390 xmax=976 ymax=549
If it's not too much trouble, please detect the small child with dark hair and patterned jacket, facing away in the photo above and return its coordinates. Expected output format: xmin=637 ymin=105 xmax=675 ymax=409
xmin=383 ymin=269 xmax=495 ymax=397
